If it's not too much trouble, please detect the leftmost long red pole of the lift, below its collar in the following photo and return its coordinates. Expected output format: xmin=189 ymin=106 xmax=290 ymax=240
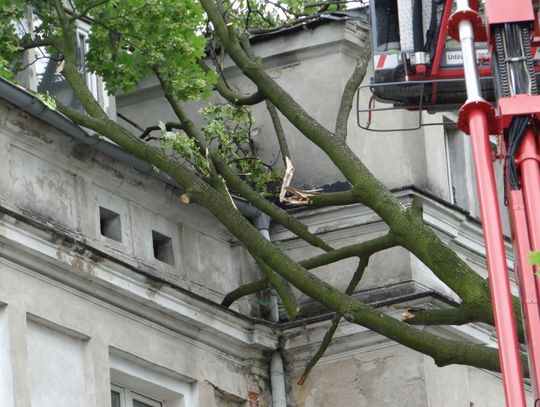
xmin=468 ymin=108 xmax=526 ymax=407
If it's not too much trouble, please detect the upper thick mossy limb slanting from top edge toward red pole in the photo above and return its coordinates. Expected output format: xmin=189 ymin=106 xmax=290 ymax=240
xmin=201 ymin=0 xmax=500 ymax=318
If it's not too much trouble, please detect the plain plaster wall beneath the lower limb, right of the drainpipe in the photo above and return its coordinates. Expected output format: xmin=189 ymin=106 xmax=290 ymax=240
xmin=282 ymin=306 xmax=532 ymax=407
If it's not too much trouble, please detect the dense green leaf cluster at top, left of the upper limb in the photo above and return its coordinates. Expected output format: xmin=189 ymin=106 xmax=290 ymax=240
xmin=87 ymin=0 xmax=215 ymax=100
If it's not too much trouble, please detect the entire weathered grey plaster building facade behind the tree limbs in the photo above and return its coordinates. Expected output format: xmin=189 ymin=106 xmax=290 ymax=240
xmin=0 ymin=11 xmax=528 ymax=407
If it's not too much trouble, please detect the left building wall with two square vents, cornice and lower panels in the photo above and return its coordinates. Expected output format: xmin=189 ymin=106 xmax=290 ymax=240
xmin=0 ymin=96 xmax=277 ymax=407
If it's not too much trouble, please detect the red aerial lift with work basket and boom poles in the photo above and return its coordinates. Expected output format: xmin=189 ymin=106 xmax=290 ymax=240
xmin=372 ymin=0 xmax=540 ymax=407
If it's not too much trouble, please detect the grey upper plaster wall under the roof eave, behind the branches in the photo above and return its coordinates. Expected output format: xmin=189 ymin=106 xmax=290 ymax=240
xmin=117 ymin=21 xmax=434 ymax=192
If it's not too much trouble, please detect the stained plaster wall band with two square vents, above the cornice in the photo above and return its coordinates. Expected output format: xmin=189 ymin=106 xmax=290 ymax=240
xmin=0 ymin=99 xmax=258 ymax=312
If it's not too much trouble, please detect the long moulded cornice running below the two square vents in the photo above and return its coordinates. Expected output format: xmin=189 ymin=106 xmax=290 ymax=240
xmin=0 ymin=204 xmax=278 ymax=358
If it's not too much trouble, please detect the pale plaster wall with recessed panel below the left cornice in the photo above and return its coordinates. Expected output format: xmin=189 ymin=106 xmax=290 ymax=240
xmin=0 ymin=252 xmax=270 ymax=407
